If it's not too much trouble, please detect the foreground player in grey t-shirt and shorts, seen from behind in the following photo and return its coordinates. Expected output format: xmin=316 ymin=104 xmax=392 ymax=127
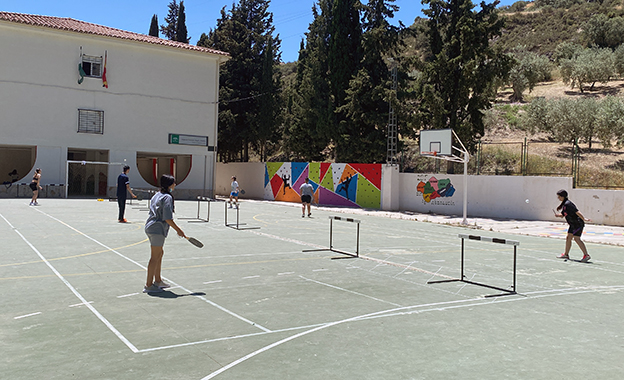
xmin=143 ymin=174 xmax=186 ymax=293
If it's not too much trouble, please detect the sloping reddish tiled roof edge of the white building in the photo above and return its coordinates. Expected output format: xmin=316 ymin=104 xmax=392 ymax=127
xmin=0 ymin=12 xmax=229 ymax=56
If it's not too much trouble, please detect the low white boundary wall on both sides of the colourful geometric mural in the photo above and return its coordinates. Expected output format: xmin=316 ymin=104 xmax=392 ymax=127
xmin=216 ymin=163 xmax=624 ymax=226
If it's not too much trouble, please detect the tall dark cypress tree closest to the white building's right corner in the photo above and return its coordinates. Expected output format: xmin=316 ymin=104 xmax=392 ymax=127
xmin=202 ymin=0 xmax=281 ymax=161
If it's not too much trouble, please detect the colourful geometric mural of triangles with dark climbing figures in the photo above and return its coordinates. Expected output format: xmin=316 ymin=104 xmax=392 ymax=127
xmin=264 ymin=162 xmax=381 ymax=209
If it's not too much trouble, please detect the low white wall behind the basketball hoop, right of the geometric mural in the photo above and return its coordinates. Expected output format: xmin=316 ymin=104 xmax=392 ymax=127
xmin=400 ymin=173 xmax=624 ymax=226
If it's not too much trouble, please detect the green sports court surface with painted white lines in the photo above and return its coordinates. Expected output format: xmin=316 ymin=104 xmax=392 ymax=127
xmin=0 ymin=199 xmax=624 ymax=380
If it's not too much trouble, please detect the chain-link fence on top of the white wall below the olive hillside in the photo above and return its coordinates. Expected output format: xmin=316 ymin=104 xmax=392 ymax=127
xmin=404 ymin=139 xmax=624 ymax=189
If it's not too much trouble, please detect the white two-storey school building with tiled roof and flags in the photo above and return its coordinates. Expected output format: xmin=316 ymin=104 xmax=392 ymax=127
xmin=0 ymin=12 xmax=229 ymax=198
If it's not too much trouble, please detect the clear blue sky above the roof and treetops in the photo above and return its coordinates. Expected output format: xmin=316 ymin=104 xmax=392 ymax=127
xmin=0 ymin=0 xmax=515 ymax=62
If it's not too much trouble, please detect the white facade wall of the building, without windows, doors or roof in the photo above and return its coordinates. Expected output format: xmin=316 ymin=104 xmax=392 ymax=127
xmin=0 ymin=22 xmax=224 ymax=199
